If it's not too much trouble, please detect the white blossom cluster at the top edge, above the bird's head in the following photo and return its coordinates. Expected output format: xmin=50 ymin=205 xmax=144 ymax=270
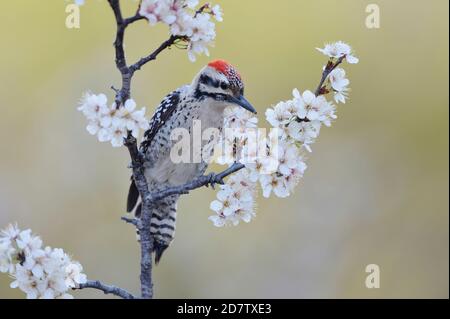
xmin=139 ymin=0 xmax=223 ymax=61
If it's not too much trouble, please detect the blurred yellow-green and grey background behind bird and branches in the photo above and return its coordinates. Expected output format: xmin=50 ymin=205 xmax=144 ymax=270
xmin=0 ymin=0 xmax=449 ymax=298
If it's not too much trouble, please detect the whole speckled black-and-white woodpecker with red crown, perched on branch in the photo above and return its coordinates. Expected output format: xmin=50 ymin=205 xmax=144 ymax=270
xmin=127 ymin=60 xmax=256 ymax=264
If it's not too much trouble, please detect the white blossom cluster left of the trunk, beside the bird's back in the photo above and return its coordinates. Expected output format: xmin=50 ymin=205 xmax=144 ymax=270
xmin=78 ymin=93 xmax=149 ymax=147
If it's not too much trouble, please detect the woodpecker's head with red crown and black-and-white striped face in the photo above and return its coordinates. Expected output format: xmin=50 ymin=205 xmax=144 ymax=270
xmin=192 ymin=60 xmax=256 ymax=114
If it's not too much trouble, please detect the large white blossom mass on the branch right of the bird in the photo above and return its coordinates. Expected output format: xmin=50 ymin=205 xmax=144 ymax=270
xmin=209 ymin=42 xmax=358 ymax=227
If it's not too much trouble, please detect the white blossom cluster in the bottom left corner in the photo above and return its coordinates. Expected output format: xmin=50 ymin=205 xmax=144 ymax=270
xmin=0 ymin=225 xmax=87 ymax=299
